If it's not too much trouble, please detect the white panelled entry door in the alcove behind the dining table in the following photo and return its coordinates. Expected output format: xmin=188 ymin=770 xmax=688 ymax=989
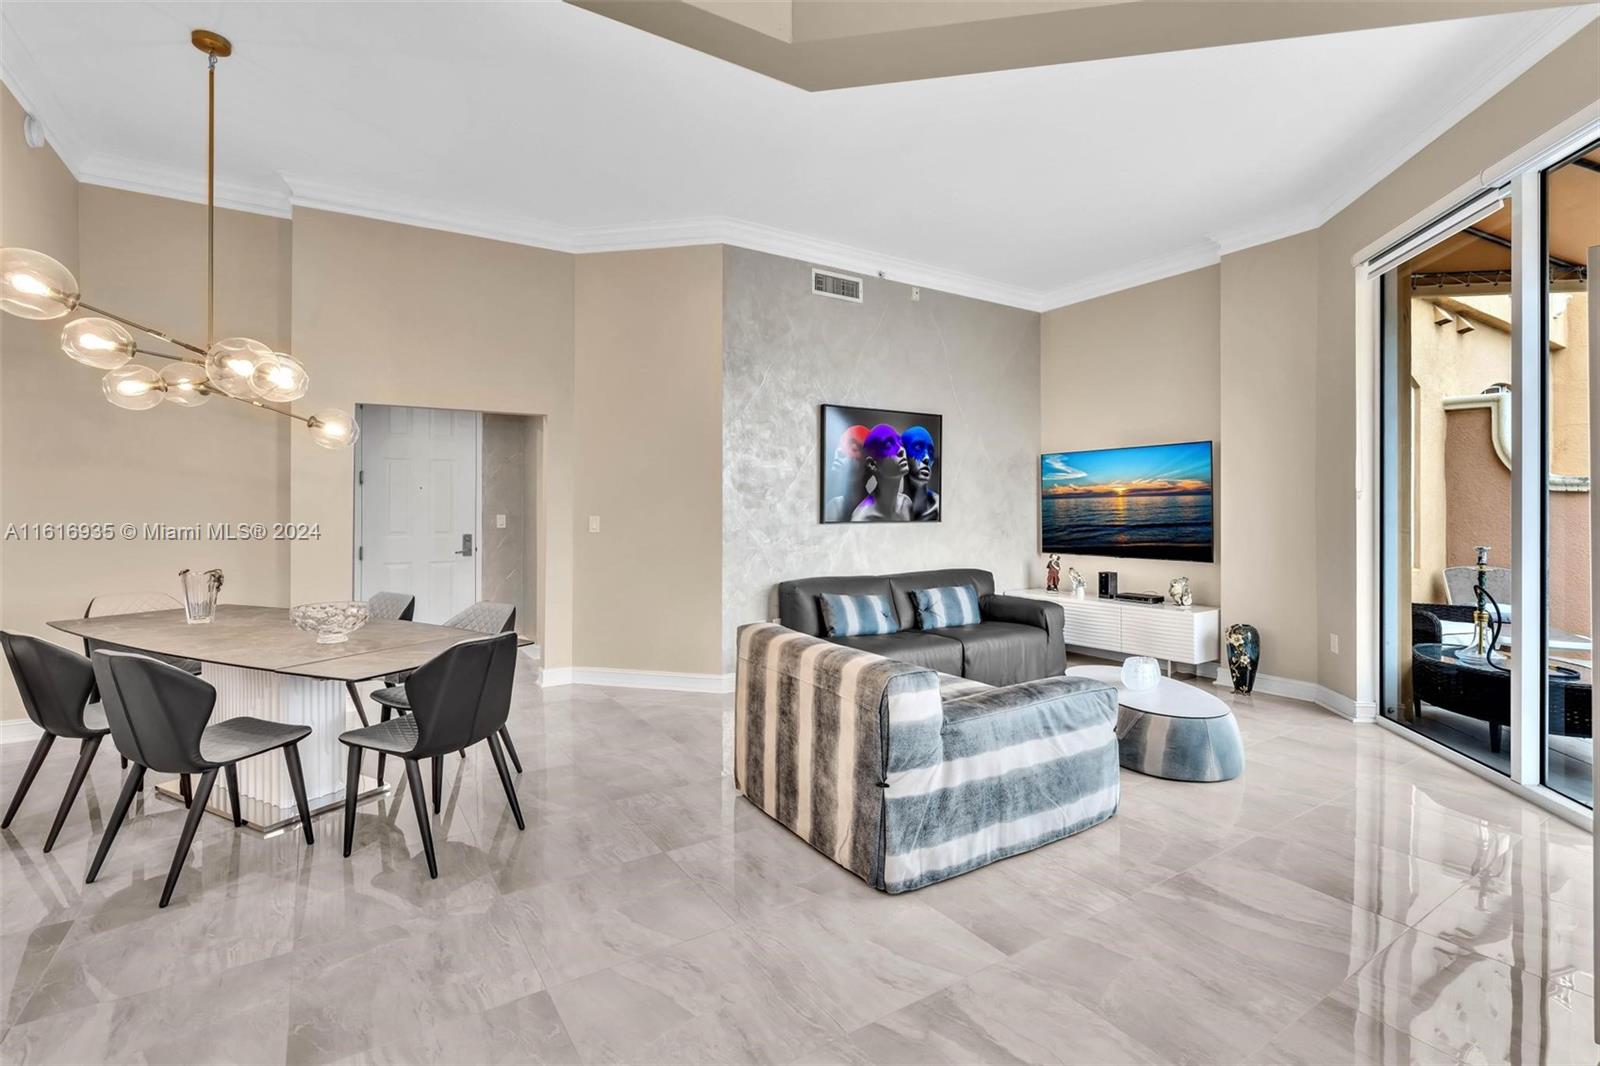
xmin=355 ymin=405 xmax=482 ymax=623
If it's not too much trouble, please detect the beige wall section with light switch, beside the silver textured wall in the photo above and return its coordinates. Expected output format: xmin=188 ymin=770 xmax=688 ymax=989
xmin=573 ymin=245 xmax=722 ymax=674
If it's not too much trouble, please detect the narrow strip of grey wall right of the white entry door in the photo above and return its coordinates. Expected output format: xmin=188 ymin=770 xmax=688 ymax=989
xmin=480 ymin=415 xmax=533 ymax=632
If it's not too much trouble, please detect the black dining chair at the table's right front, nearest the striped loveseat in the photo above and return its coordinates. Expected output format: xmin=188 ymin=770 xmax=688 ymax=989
xmin=339 ymin=632 xmax=525 ymax=877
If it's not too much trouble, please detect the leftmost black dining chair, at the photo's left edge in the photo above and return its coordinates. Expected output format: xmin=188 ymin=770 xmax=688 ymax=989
xmin=0 ymin=632 xmax=109 ymax=852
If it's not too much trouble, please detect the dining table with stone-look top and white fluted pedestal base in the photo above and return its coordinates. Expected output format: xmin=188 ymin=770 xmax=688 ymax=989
xmin=50 ymin=603 xmax=533 ymax=834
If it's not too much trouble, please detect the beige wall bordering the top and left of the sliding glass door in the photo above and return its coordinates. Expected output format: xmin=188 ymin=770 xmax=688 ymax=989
xmin=1315 ymin=22 xmax=1600 ymax=698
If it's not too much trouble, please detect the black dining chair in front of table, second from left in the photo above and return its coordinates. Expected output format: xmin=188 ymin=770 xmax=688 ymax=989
xmin=85 ymin=651 xmax=315 ymax=908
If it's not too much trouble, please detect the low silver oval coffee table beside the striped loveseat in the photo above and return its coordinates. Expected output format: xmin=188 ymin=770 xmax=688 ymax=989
xmin=1067 ymin=666 xmax=1245 ymax=781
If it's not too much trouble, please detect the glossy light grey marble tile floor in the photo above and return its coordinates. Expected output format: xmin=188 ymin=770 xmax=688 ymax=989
xmin=0 ymin=659 xmax=1597 ymax=1064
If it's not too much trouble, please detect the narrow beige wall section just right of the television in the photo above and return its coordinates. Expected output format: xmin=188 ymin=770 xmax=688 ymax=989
xmin=1218 ymin=234 xmax=1317 ymax=682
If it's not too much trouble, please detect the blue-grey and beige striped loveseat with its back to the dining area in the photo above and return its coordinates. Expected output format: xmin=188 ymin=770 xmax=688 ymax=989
xmin=733 ymin=623 xmax=1118 ymax=892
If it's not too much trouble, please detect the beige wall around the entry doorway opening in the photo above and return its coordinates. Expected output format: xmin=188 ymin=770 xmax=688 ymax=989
xmin=288 ymin=210 xmax=574 ymax=666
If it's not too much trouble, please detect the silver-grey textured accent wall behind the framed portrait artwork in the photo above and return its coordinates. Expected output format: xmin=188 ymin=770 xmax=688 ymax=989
xmin=722 ymin=248 xmax=1043 ymax=671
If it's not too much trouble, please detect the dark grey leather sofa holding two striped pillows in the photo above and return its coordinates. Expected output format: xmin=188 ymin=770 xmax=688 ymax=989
xmin=778 ymin=570 xmax=1067 ymax=685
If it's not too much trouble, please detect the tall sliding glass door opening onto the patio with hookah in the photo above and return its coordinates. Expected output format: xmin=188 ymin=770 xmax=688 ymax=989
xmin=1374 ymin=144 xmax=1600 ymax=807
